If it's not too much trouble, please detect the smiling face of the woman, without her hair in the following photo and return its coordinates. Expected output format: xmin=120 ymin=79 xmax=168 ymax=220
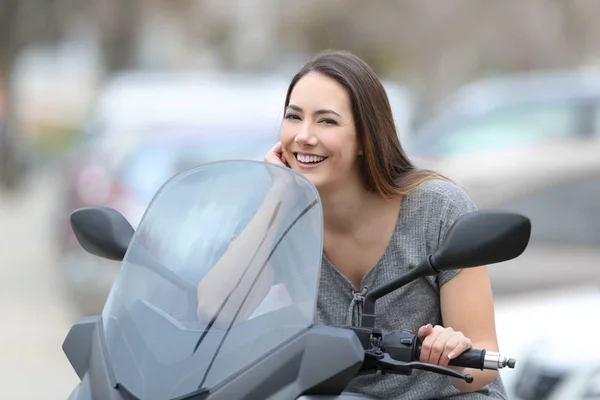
xmin=281 ymin=73 xmax=362 ymax=190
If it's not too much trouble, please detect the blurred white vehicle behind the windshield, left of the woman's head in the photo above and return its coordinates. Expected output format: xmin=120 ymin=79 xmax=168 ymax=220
xmin=60 ymin=72 xmax=285 ymax=220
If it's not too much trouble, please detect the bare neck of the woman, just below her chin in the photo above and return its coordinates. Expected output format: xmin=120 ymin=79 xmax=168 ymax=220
xmin=319 ymin=180 xmax=396 ymax=234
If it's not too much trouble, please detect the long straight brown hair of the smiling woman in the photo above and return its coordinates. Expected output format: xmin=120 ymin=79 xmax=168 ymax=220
xmin=285 ymin=50 xmax=446 ymax=198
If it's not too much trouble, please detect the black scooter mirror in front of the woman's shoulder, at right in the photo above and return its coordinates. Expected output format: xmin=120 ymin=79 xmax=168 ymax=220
xmin=429 ymin=210 xmax=531 ymax=271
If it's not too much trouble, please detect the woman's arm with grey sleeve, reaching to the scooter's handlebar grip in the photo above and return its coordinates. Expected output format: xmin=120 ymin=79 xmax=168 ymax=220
xmin=418 ymin=182 xmax=498 ymax=391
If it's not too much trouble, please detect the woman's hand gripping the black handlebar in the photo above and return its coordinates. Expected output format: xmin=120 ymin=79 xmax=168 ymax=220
xmin=417 ymin=324 xmax=472 ymax=367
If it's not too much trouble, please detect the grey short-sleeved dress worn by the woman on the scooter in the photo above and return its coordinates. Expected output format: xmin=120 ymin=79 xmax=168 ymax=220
xmin=316 ymin=180 xmax=507 ymax=399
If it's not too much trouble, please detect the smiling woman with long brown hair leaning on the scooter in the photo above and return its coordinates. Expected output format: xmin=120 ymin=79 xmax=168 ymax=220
xmin=265 ymin=51 xmax=506 ymax=399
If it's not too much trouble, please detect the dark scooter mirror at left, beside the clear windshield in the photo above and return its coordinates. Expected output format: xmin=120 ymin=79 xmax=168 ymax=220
xmin=71 ymin=207 xmax=135 ymax=261
